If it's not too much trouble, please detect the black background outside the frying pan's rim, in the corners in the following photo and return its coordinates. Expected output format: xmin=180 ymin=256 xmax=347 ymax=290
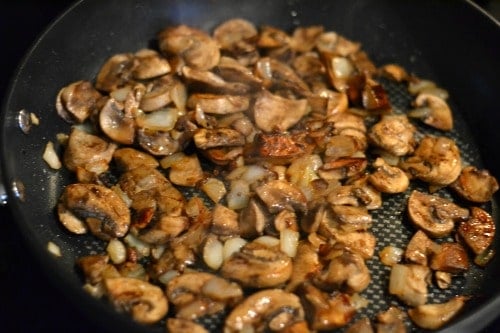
xmin=0 ymin=0 xmax=500 ymax=333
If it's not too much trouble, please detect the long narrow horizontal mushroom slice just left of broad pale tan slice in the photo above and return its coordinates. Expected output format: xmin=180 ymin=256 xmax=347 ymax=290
xmin=187 ymin=94 xmax=250 ymax=115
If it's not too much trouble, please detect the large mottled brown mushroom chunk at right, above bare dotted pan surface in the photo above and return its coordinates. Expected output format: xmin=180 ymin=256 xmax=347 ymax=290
xmin=400 ymin=136 xmax=462 ymax=186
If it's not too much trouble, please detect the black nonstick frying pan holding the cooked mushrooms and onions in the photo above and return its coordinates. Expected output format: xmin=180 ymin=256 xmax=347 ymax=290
xmin=0 ymin=0 xmax=500 ymax=332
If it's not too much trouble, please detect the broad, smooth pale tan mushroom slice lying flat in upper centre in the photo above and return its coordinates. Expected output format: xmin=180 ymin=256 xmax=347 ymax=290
xmin=253 ymin=90 xmax=308 ymax=133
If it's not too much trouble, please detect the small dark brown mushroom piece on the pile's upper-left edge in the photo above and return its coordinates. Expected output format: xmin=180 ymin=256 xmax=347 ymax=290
xmin=95 ymin=53 xmax=135 ymax=93
